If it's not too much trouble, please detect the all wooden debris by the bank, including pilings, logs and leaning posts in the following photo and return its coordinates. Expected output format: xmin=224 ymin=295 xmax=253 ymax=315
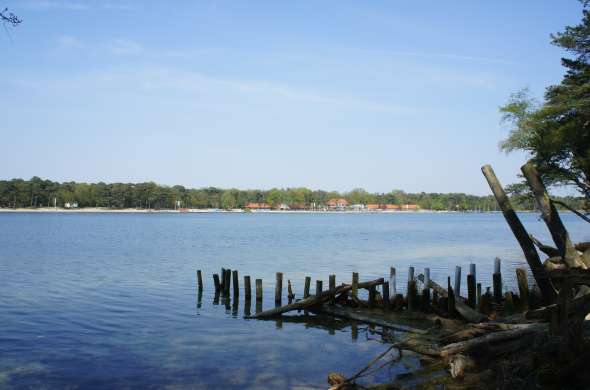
xmin=197 ymin=164 xmax=590 ymax=389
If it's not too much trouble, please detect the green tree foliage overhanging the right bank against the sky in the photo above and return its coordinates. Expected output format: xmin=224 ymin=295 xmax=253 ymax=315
xmin=500 ymin=1 xmax=590 ymax=201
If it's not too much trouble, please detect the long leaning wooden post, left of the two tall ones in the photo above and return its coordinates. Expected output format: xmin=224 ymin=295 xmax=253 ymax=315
xmin=481 ymin=165 xmax=556 ymax=303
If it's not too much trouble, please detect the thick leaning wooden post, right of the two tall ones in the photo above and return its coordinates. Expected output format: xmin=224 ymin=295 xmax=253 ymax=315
xmin=520 ymin=162 xmax=587 ymax=269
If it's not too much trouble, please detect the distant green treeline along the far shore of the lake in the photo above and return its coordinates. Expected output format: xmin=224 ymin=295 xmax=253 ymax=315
xmin=0 ymin=177 xmax=583 ymax=211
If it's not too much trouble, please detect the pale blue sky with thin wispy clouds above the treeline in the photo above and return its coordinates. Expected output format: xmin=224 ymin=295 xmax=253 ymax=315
xmin=0 ymin=0 xmax=581 ymax=194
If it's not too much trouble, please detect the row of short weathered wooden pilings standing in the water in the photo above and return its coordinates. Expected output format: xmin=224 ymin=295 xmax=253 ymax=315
xmin=197 ymin=258 xmax=531 ymax=320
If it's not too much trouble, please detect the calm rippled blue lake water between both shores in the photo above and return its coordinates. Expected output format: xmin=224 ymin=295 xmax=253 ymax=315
xmin=0 ymin=213 xmax=590 ymax=389
